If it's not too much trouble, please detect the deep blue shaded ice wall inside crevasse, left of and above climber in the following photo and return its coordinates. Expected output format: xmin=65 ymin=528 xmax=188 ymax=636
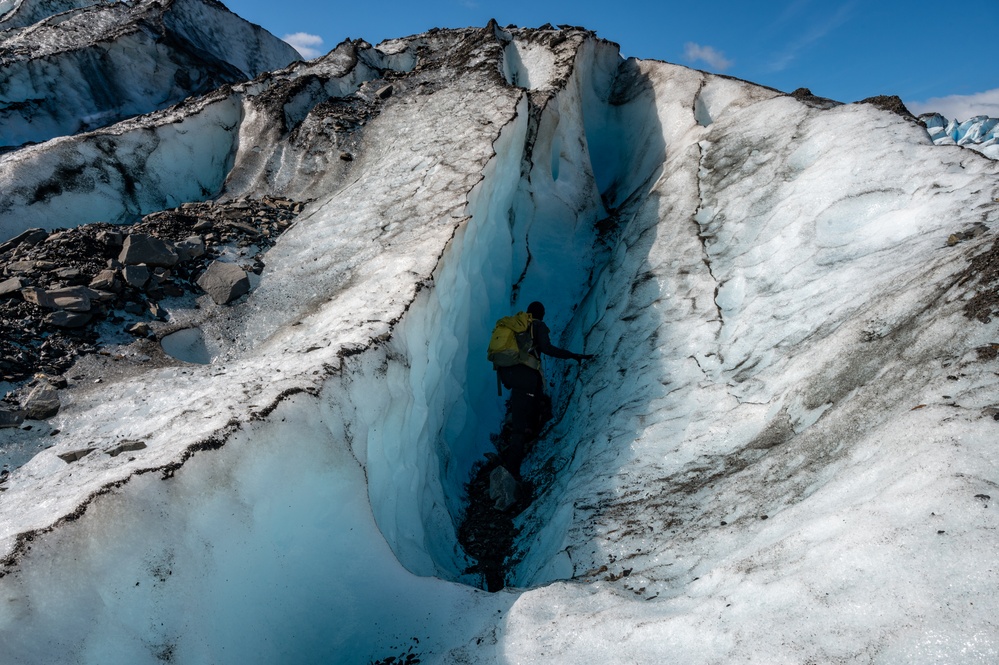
xmin=337 ymin=43 xmax=665 ymax=586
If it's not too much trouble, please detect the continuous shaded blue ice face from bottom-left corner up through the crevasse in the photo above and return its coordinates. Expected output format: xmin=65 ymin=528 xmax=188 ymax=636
xmin=0 ymin=29 xmax=665 ymax=663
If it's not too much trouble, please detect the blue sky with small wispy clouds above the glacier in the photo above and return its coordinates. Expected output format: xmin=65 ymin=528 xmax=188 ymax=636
xmin=223 ymin=0 xmax=999 ymax=120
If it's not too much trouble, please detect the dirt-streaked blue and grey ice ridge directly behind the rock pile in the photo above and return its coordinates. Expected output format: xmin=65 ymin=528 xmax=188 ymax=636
xmin=0 ymin=42 xmax=388 ymax=238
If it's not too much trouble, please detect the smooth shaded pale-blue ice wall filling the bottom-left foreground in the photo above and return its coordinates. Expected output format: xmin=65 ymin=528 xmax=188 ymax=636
xmin=0 ymin=394 xmax=510 ymax=665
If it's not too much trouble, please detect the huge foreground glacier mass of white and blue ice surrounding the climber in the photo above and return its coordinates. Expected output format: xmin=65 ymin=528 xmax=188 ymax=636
xmin=0 ymin=19 xmax=999 ymax=663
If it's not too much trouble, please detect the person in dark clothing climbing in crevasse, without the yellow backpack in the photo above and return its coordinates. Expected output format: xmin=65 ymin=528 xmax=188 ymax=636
xmin=496 ymin=301 xmax=593 ymax=481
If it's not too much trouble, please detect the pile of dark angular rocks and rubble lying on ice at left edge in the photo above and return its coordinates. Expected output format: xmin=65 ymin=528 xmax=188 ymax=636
xmin=0 ymin=196 xmax=304 ymax=382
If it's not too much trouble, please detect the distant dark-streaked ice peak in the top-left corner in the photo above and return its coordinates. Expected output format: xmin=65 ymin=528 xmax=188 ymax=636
xmin=0 ymin=0 xmax=299 ymax=149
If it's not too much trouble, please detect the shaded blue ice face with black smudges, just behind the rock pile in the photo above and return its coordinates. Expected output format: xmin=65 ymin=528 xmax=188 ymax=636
xmin=0 ymin=95 xmax=240 ymax=238
